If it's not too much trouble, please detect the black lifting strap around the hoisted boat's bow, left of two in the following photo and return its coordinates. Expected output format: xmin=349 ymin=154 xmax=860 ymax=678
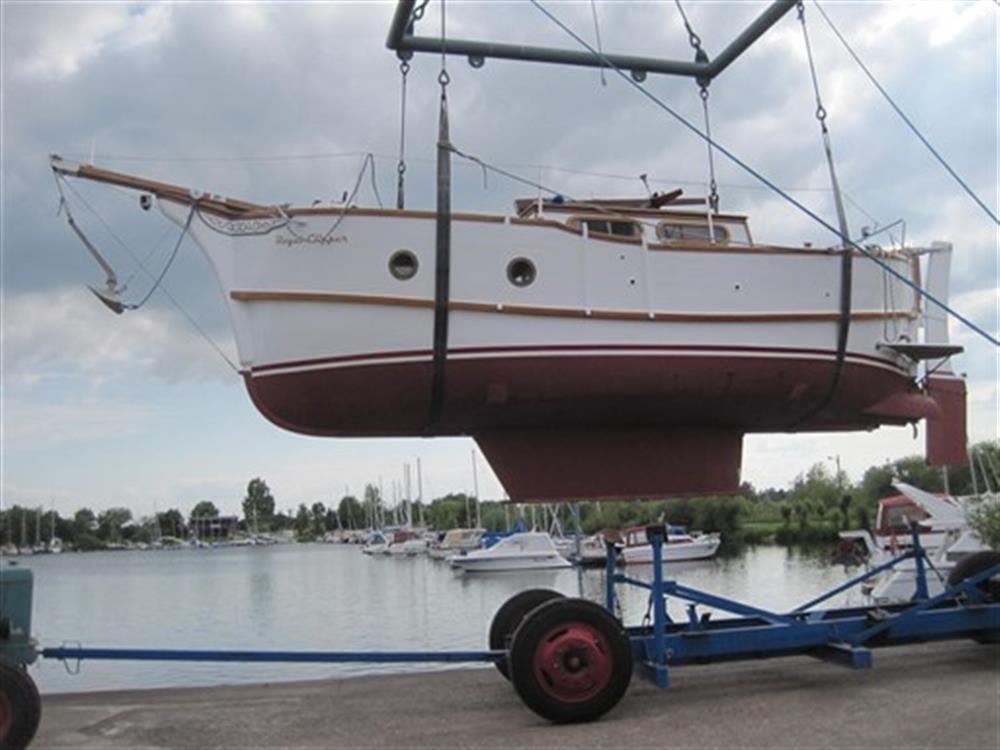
xmin=426 ymin=77 xmax=451 ymax=435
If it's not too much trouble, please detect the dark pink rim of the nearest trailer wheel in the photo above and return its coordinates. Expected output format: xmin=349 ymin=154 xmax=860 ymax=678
xmin=534 ymin=622 xmax=614 ymax=703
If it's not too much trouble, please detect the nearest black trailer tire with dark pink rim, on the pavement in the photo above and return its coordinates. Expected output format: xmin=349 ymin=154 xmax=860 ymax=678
xmin=508 ymin=599 xmax=632 ymax=724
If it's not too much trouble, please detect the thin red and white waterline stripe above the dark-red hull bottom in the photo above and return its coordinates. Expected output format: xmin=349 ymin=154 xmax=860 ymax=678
xmin=249 ymin=344 xmax=908 ymax=375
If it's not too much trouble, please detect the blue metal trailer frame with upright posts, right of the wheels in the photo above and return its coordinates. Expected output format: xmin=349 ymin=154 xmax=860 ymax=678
xmin=605 ymin=526 xmax=1000 ymax=687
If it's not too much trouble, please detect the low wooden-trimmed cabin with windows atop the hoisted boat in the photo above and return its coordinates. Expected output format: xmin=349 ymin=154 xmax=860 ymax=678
xmin=515 ymin=195 xmax=753 ymax=246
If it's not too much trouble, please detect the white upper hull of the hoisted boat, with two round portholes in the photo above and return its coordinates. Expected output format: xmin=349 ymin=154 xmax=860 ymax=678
xmin=161 ymin=202 xmax=918 ymax=377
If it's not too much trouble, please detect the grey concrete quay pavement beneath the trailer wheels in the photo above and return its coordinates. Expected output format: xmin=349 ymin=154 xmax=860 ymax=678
xmin=32 ymin=641 xmax=1000 ymax=750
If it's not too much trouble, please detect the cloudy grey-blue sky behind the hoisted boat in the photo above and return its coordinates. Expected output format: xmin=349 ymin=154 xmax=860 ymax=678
xmin=0 ymin=0 xmax=1000 ymax=516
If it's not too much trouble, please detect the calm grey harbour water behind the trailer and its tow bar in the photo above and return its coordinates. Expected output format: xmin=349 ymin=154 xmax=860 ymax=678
xmin=15 ymin=544 xmax=858 ymax=693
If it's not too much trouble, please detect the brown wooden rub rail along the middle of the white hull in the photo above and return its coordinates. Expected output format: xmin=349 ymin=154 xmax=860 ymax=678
xmin=229 ymin=290 xmax=915 ymax=323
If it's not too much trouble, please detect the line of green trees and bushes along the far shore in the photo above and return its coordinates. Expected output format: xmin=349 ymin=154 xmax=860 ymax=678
xmin=0 ymin=441 xmax=1000 ymax=550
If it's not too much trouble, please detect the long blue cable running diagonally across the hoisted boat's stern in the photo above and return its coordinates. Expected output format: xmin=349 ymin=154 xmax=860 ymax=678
xmin=530 ymin=0 xmax=1000 ymax=347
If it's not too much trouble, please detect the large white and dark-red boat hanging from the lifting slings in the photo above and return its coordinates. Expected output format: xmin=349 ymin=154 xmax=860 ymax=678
xmin=50 ymin=0 xmax=966 ymax=502
